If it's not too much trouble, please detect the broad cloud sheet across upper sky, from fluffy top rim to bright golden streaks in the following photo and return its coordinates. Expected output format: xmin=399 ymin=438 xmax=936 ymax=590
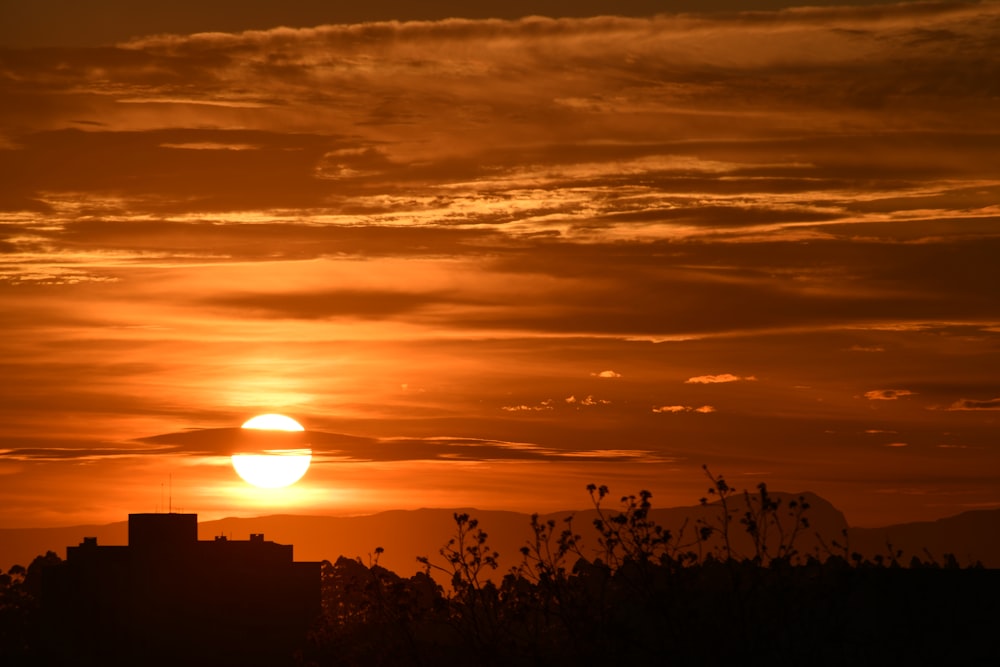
xmin=0 ymin=4 xmax=997 ymax=248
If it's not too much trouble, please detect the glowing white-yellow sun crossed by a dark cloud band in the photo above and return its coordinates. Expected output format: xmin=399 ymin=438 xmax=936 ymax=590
xmin=232 ymin=414 xmax=312 ymax=489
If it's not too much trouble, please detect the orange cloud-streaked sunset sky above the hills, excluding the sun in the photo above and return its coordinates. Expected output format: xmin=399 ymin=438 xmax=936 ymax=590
xmin=0 ymin=0 xmax=1000 ymax=528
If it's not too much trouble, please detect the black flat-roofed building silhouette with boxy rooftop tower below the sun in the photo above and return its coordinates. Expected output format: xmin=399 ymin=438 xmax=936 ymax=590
xmin=42 ymin=513 xmax=321 ymax=666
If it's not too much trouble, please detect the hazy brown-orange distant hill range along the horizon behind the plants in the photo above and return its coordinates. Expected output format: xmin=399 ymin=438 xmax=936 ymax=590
xmin=0 ymin=493 xmax=1000 ymax=576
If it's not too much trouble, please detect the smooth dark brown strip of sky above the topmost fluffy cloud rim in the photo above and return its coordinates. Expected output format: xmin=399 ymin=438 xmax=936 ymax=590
xmin=0 ymin=0 xmax=992 ymax=47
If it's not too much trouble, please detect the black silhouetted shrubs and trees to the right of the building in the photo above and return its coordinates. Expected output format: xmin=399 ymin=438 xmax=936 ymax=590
xmin=298 ymin=468 xmax=1000 ymax=666
